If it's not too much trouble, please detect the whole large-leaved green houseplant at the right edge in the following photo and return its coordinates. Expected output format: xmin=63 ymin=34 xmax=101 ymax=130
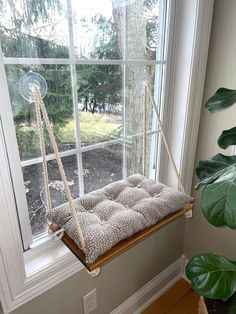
xmin=186 ymin=88 xmax=236 ymax=313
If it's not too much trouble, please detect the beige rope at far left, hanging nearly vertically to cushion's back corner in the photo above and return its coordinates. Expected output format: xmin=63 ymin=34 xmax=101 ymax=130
xmin=34 ymin=94 xmax=52 ymax=213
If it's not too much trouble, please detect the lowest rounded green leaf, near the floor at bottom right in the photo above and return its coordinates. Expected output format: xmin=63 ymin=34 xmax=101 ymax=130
xmin=186 ymin=253 xmax=236 ymax=299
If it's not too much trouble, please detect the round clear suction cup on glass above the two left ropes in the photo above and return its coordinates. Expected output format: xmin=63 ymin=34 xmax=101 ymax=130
xmin=18 ymin=71 xmax=47 ymax=102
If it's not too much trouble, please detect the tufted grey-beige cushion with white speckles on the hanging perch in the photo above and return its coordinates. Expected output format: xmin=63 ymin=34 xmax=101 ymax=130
xmin=47 ymin=174 xmax=193 ymax=264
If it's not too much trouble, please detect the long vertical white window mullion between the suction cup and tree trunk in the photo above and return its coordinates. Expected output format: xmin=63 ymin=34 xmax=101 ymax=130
xmin=67 ymin=0 xmax=84 ymax=195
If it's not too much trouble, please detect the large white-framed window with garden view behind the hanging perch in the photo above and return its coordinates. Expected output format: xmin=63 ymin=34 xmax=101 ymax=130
xmin=0 ymin=0 xmax=212 ymax=310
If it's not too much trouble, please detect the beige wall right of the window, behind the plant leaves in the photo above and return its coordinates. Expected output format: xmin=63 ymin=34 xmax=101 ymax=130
xmin=184 ymin=0 xmax=236 ymax=259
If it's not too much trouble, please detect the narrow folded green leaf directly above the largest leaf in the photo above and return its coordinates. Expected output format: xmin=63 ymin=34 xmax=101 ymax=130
xmin=196 ymin=154 xmax=236 ymax=188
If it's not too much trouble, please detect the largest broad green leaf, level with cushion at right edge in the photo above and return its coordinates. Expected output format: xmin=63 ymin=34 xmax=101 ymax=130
xmin=201 ymin=164 xmax=236 ymax=229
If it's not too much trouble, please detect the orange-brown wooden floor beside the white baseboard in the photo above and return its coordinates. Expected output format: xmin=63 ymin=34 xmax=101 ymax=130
xmin=143 ymin=279 xmax=191 ymax=314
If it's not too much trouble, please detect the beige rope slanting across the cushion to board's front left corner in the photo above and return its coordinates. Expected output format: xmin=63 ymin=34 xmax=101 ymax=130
xmin=33 ymin=85 xmax=85 ymax=251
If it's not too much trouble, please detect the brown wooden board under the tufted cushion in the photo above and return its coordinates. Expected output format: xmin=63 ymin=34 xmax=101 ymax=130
xmin=50 ymin=204 xmax=193 ymax=271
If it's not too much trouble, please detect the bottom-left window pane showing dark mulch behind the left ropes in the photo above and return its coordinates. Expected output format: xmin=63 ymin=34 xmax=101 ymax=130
xmin=22 ymin=155 xmax=79 ymax=236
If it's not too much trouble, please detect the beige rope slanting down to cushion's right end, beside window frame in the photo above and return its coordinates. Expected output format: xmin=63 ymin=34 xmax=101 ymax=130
xmin=146 ymin=84 xmax=186 ymax=194
